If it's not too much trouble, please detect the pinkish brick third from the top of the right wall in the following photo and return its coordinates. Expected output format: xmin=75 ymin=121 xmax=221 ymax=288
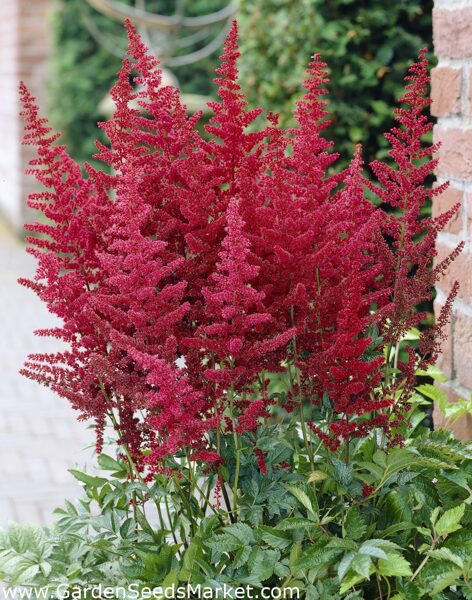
xmin=434 ymin=125 xmax=472 ymax=180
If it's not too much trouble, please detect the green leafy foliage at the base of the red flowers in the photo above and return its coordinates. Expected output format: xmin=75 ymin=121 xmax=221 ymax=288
xmin=0 ymin=423 xmax=472 ymax=600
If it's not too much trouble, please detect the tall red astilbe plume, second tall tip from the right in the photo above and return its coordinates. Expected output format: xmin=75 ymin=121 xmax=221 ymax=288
xmin=251 ymin=56 xmax=342 ymax=335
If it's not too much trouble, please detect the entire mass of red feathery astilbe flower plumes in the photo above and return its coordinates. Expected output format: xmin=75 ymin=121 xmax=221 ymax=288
xmin=21 ymin=23 xmax=460 ymax=464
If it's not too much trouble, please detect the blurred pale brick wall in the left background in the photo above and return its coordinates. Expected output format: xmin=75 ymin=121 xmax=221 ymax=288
xmin=0 ymin=0 xmax=49 ymax=231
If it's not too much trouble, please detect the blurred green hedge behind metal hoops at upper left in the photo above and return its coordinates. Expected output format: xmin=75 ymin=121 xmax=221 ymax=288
xmin=48 ymin=0 xmax=226 ymax=161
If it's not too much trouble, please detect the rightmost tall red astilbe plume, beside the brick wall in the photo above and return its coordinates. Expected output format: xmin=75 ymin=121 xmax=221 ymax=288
xmin=368 ymin=49 xmax=464 ymax=394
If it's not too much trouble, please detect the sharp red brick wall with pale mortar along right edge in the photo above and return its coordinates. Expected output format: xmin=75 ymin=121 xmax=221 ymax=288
xmin=431 ymin=0 xmax=472 ymax=438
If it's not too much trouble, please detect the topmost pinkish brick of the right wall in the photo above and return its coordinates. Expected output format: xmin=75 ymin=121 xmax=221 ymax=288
xmin=433 ymin=7 xmax=472 ymax=58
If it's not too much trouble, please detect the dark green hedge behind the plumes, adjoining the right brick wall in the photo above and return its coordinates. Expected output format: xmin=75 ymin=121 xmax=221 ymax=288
xmin=239 ymin=0 xmax=433 ymax=166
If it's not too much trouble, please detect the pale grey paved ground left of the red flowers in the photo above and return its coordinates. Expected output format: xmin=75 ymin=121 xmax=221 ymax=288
xmin=0 ymin=223 xmax=93 ymax=527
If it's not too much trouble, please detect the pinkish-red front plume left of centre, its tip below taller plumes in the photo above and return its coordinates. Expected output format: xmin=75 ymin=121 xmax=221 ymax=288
xmin=85 ymin=166 xmax=194 ymax=465
